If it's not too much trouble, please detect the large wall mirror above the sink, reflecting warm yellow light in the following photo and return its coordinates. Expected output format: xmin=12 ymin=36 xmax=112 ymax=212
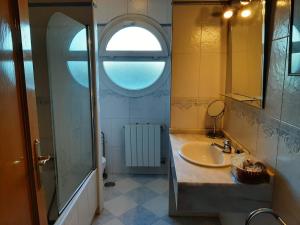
xmin=226 ymin=0 xmax=269 ymax=108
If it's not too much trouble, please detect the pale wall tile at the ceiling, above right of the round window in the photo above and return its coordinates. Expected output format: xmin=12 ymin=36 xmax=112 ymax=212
xmin=148 ymin=0 xmax=172 ymax=24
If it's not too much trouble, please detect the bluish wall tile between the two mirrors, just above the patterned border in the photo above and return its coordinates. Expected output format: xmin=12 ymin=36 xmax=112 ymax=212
xmin=265 ymin=38 xmax=288 ymax=119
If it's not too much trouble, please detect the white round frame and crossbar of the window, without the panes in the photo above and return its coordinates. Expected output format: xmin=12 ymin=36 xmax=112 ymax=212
xmin=99 ymin=15 xmax=170 ymax=97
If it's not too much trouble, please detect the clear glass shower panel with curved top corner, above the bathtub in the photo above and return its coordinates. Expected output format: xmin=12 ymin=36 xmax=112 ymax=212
xmin=47 ymin=13 xmax=94 ymax=212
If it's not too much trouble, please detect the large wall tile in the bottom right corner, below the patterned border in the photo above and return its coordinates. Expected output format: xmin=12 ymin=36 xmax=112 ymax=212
xmin=274 ymin=123 xmax=300 ymax=225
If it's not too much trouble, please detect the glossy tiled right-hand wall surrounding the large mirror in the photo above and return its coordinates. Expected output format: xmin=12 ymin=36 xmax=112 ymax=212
xmin=224 ymin=0 xmax=300 ymax=225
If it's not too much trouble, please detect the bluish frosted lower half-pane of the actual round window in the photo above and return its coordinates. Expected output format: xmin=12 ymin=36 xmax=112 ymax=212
xmin=103 ymin=61 xmax=165 ymax=90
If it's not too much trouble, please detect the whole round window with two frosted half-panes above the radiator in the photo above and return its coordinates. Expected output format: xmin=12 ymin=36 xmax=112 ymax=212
xmin=100 ymin=16 xmax=169 ymax=95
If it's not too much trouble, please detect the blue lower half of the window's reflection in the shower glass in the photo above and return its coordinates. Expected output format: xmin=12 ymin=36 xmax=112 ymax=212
xmin=68 ymin=61 xmax=89 ymax=88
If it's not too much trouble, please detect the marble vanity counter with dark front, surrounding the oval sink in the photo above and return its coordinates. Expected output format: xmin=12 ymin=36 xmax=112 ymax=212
xmin=169 ymin=133 xmax=272 ymax=215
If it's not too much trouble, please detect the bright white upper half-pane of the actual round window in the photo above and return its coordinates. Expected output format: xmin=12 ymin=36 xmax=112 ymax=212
xmin=106 ymin=26 xmax=162 ymax=51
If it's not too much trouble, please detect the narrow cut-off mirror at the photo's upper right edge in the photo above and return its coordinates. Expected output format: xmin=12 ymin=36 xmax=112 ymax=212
xmin=289 ymin=0 xmax=300 ymax=76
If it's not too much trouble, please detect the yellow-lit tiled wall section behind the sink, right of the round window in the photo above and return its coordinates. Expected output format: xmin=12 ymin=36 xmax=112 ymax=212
xmin=171 ymin=5 xmax=227 ymax=130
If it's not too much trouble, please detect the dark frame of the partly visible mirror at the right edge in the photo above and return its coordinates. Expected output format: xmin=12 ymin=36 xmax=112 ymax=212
xmin=288 ymin=0 xmax=300 ymax=76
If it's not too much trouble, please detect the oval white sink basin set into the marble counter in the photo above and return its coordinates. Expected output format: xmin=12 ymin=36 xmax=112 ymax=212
xmin=179 ymin=141 xmax=231 ymax=167
